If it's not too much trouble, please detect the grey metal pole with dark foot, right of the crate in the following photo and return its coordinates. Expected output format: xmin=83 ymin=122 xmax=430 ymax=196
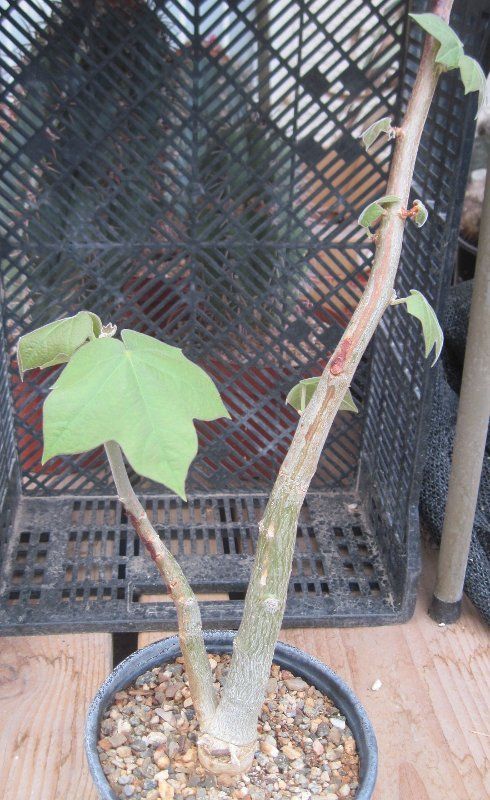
xmin=429 ymin=155 xmax=490 ymax=622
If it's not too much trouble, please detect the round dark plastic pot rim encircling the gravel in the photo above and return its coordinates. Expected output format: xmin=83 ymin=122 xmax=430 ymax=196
xmin=85 ymin=631 xmax=378 ymax=800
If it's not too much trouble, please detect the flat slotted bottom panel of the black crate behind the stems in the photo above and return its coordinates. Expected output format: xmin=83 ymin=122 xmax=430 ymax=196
xmin=0 ymin=494 xmax=395 ymax=632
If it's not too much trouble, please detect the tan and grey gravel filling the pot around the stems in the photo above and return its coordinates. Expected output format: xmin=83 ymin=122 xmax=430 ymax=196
xmin=98 ymin=655 xmax=359 ymax=800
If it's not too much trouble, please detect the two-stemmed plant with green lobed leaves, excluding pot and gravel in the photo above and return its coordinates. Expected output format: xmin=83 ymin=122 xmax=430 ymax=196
xmin=18 ymin=0 xmax=485 ymax=773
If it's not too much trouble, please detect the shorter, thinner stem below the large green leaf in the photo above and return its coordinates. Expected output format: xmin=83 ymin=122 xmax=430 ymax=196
xmin=105 ymin=442 xmax=217 ymax=725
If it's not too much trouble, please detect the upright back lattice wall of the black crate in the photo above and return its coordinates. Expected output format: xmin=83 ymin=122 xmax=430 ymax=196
xmin=0 ymin=0 xmax=405 ymax=494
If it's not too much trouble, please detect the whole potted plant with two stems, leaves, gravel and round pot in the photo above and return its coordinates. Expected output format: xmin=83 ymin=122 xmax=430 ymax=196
xmin=18 ymin=0 xmax=484 ymax=800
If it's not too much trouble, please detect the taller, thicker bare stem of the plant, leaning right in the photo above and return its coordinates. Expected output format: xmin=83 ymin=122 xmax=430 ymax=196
xmin=200 ymin=0 xmax=452 ymax=771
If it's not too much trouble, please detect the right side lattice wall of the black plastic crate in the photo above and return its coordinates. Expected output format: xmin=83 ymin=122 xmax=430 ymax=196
xmin=361 ymin=2 xmax=490 ymax=564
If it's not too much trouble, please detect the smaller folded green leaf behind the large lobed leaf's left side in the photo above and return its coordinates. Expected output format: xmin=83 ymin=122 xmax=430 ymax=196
xmin=17 ymin=311 xmax=102 ymax=378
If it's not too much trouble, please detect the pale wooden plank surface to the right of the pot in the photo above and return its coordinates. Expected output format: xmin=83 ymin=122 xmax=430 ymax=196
xmin=139 ymin=553 xmax=490 ymax=800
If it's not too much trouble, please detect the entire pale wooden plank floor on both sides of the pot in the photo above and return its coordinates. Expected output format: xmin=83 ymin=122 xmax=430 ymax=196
xmin=0 ymin=552 xmax=490 ymax=800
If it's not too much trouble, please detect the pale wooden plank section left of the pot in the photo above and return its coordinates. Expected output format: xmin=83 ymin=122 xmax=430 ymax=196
xmin=0 ymin=634 xmax=112 ymax=800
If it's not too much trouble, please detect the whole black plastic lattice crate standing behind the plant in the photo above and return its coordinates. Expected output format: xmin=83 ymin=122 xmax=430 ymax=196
xmin=0 ymin=0 xmax=488 ymax=633
